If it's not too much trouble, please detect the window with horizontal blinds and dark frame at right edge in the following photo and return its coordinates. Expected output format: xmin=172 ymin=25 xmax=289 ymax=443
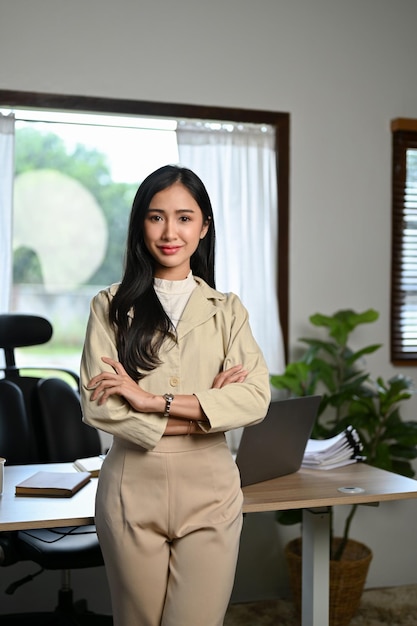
xmin=391 ymin=119 xmax=417 ymax=366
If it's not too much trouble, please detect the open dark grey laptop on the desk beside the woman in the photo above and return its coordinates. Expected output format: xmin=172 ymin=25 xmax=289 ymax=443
xmin=236 ymin=396 xmax=321 ymax=487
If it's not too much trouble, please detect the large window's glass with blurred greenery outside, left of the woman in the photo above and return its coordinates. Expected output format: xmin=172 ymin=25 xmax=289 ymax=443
xmin=6 ymin=107 xmax=178 ymax=371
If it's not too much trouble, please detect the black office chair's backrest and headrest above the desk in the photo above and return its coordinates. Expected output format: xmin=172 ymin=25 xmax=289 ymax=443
xmin=0 ymin=313 xmax=101 ymax=465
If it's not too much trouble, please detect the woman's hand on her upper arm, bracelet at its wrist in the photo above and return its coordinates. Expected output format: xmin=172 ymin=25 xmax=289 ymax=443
xmin=88 ymin=356 xmax=158 ymax=412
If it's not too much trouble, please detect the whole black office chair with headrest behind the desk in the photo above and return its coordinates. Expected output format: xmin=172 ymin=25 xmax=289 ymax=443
xmin=0 ymin=314 xmax=112 ymax=626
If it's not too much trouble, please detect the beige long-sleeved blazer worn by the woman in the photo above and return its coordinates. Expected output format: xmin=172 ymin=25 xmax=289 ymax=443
xmin=81 ymin=278 xmax=271 ymax=450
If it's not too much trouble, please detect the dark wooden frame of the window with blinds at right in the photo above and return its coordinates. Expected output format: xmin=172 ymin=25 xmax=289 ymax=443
xmin=390 ymin=118 xmax=417 ymax=367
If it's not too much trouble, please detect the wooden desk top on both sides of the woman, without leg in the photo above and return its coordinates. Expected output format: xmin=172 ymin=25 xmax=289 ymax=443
xmin=0 ymin=463 xmax=417 ymax=531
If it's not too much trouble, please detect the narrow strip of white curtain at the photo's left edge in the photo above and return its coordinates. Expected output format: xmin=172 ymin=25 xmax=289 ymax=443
xmin=0 ymin=113 xmax=15 ymax=313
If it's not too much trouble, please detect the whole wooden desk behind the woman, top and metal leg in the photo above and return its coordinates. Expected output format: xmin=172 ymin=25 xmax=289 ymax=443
xmin=0 ymin=463 xmax=417 ymax=626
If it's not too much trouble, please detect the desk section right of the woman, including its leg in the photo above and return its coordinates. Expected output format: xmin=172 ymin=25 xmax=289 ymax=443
xmin=243 ymin=463 xmax=417 ymax=626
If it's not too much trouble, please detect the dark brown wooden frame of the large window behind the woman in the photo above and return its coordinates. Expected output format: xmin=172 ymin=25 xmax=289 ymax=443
xmin=0 ymin=91 xmax=289 ymax=368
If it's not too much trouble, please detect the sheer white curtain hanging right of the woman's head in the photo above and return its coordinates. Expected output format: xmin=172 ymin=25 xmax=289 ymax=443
xmin=177 ymin=122 xmax=285 ymax=374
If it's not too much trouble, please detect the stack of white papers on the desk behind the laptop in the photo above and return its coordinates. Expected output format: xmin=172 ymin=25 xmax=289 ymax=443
xmin=301 ymin=426 xmax=366 ymax=469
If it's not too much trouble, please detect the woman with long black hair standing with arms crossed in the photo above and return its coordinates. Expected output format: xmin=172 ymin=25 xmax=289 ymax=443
xmin=81 ymin=166 xmax=270 ymax=626
